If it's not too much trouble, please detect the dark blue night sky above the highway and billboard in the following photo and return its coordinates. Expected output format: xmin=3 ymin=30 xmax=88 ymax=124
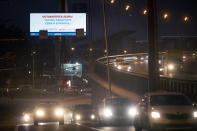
xmin=0 ymin=0 xmax=197 ymax=40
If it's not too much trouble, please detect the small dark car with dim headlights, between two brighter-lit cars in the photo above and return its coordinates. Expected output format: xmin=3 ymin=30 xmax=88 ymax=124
xmin=73 ymin=104 xmax=98 ymax=123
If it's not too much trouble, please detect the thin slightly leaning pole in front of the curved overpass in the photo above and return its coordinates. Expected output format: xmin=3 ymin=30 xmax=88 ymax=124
xmin=102 ymin=0 xmax=112 ymax=97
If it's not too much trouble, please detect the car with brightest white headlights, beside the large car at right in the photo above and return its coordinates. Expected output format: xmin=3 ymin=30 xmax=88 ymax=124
xmin=99 ymin=97 xmax=137 ymax=125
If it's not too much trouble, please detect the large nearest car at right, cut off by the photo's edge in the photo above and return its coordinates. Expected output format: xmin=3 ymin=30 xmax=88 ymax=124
xmin=134 ymin=92 xmax=197 ymax=131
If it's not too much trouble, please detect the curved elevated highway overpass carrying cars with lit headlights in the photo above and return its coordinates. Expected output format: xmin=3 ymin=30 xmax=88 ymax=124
xmin=89 ymin=52 xmax=197 ymax=106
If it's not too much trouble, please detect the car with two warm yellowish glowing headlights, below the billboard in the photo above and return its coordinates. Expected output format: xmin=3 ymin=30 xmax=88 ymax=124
xmin=33 ymin=102 xmax=65 ymax=125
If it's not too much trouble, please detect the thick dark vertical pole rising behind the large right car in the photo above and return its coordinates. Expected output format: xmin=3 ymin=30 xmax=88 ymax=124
xmin=147 ymin=0 xmax=159 ymax=92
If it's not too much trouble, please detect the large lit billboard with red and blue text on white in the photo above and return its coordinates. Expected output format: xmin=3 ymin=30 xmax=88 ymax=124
xmin=30 ymin=13 xmax=86 ymax=36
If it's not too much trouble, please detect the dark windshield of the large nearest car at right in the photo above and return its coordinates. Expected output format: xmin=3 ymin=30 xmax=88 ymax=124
xmin=150 ymin=95 xmax=191 ymax=106
